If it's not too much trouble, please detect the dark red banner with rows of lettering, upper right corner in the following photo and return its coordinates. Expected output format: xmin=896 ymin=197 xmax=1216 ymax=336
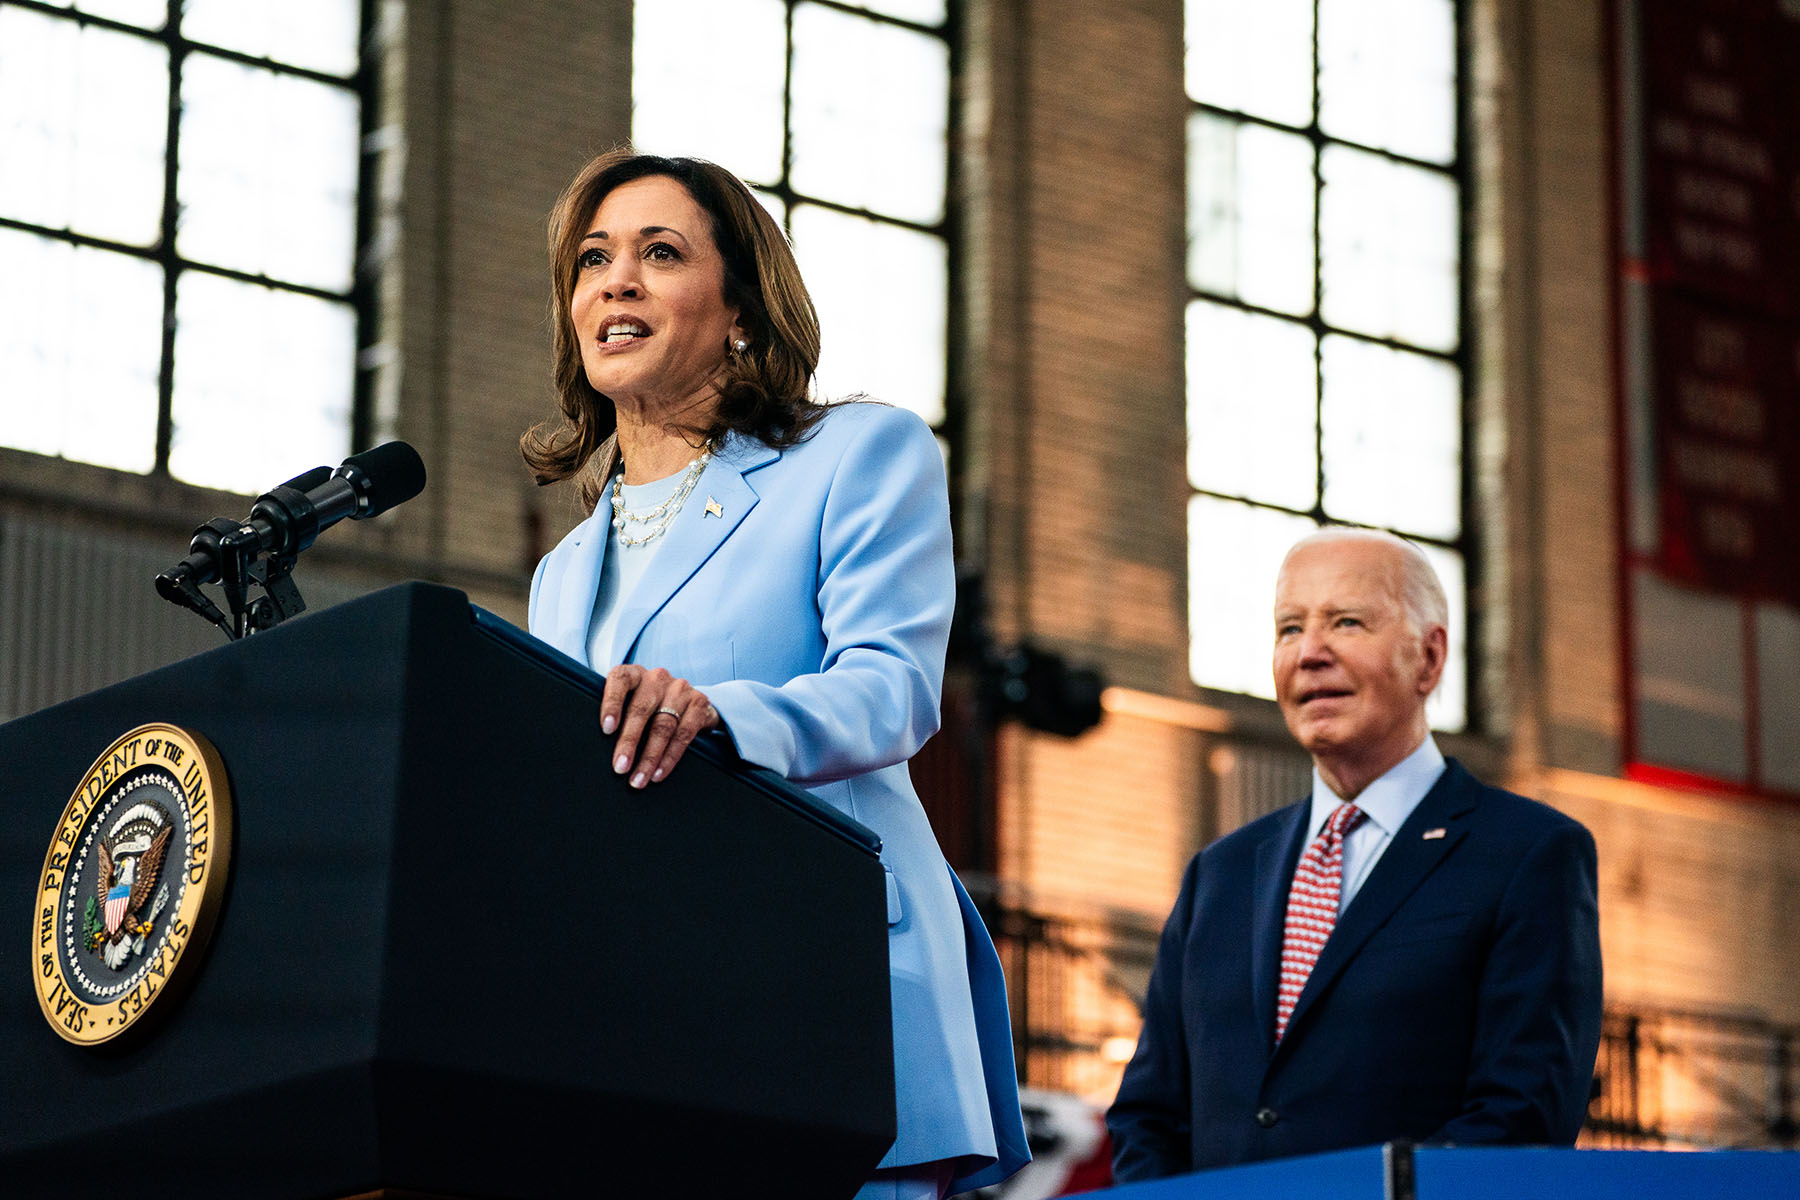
xmin=1633 ymin=0 xmax=1800 ymax=603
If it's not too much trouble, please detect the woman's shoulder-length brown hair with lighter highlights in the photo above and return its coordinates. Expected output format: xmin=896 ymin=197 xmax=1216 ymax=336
xmin=518 ymin=148 xmax=824 ymax=513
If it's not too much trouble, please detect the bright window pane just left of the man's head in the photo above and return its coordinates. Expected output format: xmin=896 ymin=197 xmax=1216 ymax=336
xmin=1188 ymin=497 xmax=1318 ymax=700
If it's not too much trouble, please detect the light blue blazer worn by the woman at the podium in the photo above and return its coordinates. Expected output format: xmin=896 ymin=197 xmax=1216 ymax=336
xmin=531 ymin=403 xmax=1030 ymax=1191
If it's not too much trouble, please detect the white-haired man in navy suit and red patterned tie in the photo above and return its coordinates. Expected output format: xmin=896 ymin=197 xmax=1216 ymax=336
xmin=1107 ymin=529 xmax=1600 ymax=1182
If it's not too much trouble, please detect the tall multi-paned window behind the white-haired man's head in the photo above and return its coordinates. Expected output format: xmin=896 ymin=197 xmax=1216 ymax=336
xmin=1186 ymin=0 xmax=1469 ymax=730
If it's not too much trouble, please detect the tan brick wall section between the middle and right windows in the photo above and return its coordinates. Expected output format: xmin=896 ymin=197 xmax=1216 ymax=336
xmin=965 ymin=0 xmax=1186 ymax=691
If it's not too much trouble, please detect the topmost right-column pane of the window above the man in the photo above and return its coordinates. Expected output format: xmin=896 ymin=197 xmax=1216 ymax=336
xmin=1319 ymin=0 xmax=1456 ymax=166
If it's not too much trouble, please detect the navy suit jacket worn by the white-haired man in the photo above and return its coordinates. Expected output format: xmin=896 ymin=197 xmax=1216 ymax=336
xmin=1107 ymin=759 xmax=1600 ymax=1182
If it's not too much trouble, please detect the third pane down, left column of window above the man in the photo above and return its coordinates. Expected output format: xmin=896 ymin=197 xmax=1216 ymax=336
xmin=1188 ymin=300 xmax=1318 ymax=509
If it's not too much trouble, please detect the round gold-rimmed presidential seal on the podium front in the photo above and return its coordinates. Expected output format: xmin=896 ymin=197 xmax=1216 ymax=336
xmin=31 ymin=725 xmax=230 ymax=1045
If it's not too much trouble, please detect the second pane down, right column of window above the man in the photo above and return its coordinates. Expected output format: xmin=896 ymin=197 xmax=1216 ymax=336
xmin=1319 ymin=146 xmax=1460 ymax=351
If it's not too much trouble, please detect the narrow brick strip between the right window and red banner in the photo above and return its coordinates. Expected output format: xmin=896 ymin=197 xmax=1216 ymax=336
xmin=1496 ymin=4 xmax=1620 ymax=770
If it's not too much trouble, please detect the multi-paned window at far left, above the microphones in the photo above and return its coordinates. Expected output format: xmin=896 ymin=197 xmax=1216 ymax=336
xmin=0 ymin=0 xmax=369 ymax=491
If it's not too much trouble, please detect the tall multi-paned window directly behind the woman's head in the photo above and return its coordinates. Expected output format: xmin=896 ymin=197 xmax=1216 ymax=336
xmin=632 ymin=0 xmax=950 ymax=430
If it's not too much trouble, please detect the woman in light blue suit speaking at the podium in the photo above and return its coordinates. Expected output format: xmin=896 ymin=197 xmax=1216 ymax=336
xmin=520 ymin=149 xmax=1028 ymax=1200
